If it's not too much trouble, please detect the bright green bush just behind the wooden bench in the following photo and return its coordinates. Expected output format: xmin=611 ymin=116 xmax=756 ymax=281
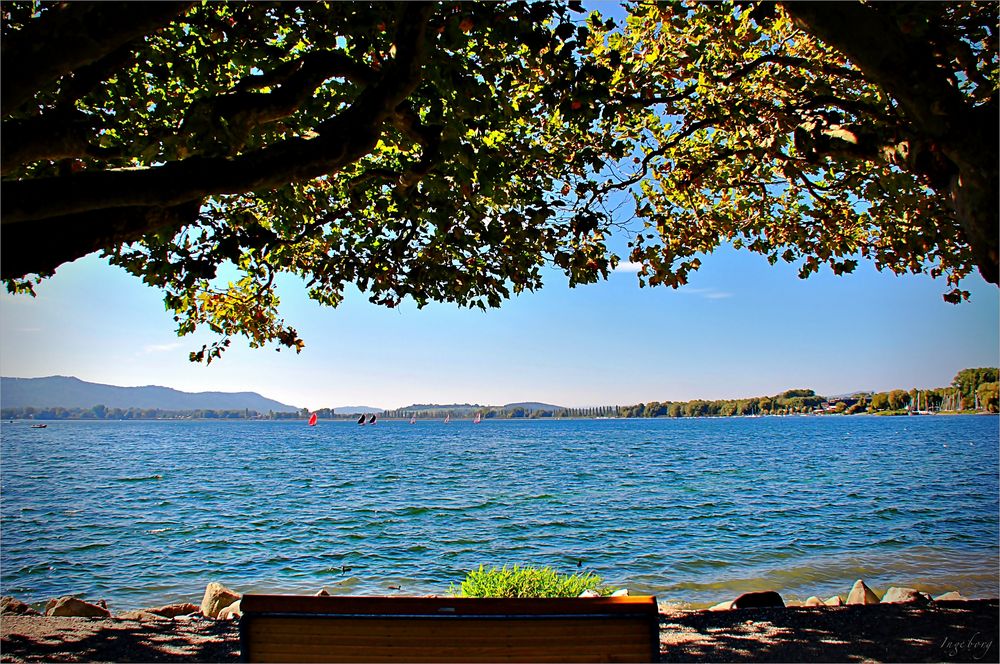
xmin=449 ymin=565 xmax=612 ymax=597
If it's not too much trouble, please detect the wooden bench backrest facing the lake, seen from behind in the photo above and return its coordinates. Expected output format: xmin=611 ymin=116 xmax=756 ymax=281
xmin=240 ymin=594 xmax=660 ymax=662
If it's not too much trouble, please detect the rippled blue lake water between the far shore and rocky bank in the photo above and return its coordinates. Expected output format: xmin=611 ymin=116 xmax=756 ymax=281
xmin=0 ymin=416 xmax=1000 ymax=610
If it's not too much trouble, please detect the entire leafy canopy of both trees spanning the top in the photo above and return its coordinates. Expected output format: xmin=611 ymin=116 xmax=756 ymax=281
xmin=0 ymin=1 xmax=998 ymax=361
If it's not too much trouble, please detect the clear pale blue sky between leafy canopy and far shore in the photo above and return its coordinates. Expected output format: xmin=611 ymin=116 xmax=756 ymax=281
xmin=0 ymin=240 xmax=1000 ymax=408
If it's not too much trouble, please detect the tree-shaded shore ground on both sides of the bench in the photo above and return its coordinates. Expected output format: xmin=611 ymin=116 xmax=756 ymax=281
xmin=0 ymin=599 xmax=1000 ymax=662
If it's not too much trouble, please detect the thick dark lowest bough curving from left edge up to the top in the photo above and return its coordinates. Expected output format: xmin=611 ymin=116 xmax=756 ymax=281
xmin=0 ymin=3 xmax=432 ymax=278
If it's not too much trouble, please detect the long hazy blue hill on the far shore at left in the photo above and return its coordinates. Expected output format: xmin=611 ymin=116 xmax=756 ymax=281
xmin=0 ymin=376 xmax=298 ymax=413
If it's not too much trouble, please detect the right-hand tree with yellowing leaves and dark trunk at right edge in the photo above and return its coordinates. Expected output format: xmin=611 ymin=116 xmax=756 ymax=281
xmin=594 ymin=0 xmax=1000 ymax=302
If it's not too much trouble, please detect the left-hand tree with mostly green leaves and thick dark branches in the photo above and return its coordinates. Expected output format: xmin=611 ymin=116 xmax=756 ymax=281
xmin=2 ymin=2 xmax=609 ymax=361
